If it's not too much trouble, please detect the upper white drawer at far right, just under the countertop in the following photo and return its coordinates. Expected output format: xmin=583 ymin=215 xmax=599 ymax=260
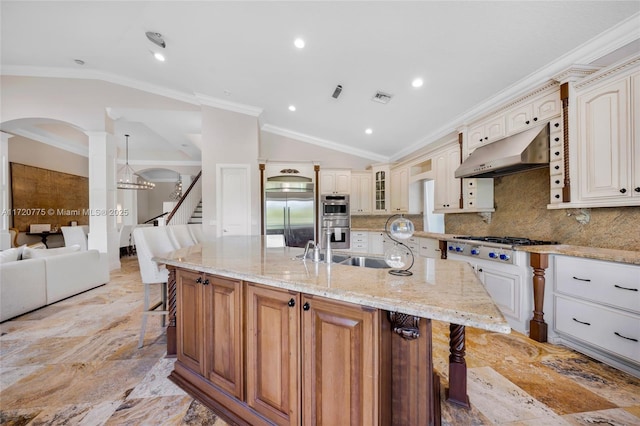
xmin=555 ymin=256 xmax=640 ymax=313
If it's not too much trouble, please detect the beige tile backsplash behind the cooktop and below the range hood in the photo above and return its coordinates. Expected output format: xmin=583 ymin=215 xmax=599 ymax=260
xmin=445 ymin=169 xmax=640 ymax=251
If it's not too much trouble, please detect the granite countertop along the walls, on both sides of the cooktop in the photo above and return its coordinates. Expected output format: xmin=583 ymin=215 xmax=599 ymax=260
xmin=353 ymin=228 xmax=640 ymax=265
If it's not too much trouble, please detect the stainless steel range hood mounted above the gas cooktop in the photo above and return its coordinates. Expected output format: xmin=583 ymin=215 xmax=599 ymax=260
xmin=455 ymin=124 xmax=549 ymax=178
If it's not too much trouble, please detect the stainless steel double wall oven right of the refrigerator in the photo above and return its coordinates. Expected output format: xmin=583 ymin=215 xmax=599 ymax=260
xmin=319 ymin=194 xmax=351 ymax=249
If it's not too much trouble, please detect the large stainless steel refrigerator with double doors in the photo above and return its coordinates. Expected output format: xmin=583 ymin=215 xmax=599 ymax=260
xmin=265 ymin=183 xmax=315 ymax=247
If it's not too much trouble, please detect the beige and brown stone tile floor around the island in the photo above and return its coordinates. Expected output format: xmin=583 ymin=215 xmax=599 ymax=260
xmin=0 ymin=258 xmax=640 ymax=426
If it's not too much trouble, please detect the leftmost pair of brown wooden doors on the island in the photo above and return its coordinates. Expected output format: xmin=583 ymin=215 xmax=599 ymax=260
xmin=176 ymin=270 xmax=244 ymax=397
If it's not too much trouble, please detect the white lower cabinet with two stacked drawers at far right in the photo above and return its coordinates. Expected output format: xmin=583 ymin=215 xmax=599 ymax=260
xmin=553 ymin=256 xmax=640 ymax=377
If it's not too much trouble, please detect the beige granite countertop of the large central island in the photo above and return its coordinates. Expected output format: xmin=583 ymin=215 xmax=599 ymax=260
xmin=154 ymin=236 xmax=511 ymax=333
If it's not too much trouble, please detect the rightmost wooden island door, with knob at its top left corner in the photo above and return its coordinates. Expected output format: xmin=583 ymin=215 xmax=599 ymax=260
xmin=302 ymin=296 xmax=380 ymax=425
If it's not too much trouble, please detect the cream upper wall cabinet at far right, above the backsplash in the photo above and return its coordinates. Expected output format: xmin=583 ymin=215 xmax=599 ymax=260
xmin=577 ymin=72 xmax=640 ymax=206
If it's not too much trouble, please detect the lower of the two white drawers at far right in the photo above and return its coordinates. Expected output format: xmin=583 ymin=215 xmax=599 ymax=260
xmin=555 ymin=296 xmax=640 ymax=362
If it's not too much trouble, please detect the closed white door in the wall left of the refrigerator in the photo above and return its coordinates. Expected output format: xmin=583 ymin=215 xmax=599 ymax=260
xmin=216 ymin=164 xmax=251 ymax=236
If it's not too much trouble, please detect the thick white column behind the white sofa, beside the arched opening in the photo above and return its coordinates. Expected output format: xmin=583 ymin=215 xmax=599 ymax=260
xmin=86 ymin=132 xmax=120 ymax=270
